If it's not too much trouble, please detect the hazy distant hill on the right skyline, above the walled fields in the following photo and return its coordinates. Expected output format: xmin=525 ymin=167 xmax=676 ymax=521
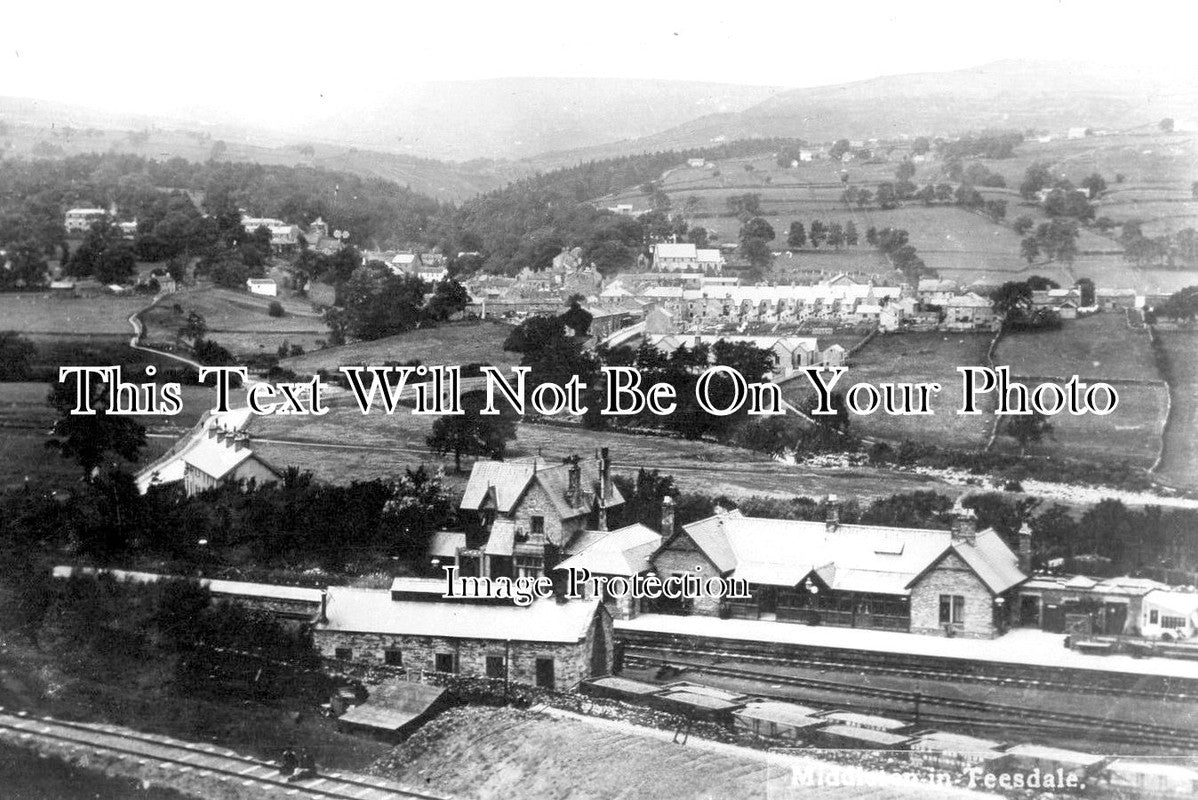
xmin=536 ymin=61 xmax=1198 ymax=165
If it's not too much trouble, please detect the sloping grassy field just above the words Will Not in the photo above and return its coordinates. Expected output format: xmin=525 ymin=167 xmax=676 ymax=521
xmin=280 ymin=321 xmax=520 ymax=375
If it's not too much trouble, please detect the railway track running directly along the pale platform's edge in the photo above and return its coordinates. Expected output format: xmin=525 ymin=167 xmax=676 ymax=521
xmin=619 ymin=631 xmax=1198 ymax=702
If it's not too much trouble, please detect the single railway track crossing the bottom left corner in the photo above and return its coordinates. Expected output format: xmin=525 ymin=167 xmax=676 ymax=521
xmin=0 ymin=709 xmax=447 ymax=800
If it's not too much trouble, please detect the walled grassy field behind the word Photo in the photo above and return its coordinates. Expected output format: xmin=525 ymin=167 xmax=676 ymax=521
xmin=994 ymin=314 xmax=1168 ymax=468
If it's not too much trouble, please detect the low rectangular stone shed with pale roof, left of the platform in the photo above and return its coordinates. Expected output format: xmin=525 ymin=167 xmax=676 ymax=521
xmin=313 ymin=581 xmax=612 ymax=689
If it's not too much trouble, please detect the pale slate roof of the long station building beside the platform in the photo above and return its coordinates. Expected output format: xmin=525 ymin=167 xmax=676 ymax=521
xmin=683 ymin=511 xmax=1025 ymax=595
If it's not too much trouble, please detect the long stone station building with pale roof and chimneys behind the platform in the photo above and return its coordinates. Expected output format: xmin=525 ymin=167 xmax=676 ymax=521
xmin=651 ymin=498 xmax=1027 ymax=637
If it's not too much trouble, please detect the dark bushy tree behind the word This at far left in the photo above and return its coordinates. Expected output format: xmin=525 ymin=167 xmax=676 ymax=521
xmin=46 ymin=378 xmax=146 ymax=480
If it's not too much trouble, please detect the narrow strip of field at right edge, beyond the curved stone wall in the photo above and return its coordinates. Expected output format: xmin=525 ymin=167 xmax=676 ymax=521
xmin=1156 ymin=331 xmax=1198 ymax=487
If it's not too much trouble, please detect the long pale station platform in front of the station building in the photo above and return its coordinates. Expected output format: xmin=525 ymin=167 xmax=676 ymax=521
xmin=616 ymin=614 xmax=1198 ymax=680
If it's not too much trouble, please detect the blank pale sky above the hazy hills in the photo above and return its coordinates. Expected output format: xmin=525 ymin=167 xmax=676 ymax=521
xmin=0 ymin=0 xmax=1198 ymax=126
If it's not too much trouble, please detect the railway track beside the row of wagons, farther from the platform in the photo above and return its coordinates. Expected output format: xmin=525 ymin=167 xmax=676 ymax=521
xmin=625 ymin=656 xmax=1198 ymax=749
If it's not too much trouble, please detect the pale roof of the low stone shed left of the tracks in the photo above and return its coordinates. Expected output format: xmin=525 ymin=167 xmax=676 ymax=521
xmin=316 ymin=586 xmax=600 ymax=643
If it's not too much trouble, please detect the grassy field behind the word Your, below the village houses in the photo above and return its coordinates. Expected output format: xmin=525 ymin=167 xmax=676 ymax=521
xmin=782 ymin=333 xmax=993 ymax=448
